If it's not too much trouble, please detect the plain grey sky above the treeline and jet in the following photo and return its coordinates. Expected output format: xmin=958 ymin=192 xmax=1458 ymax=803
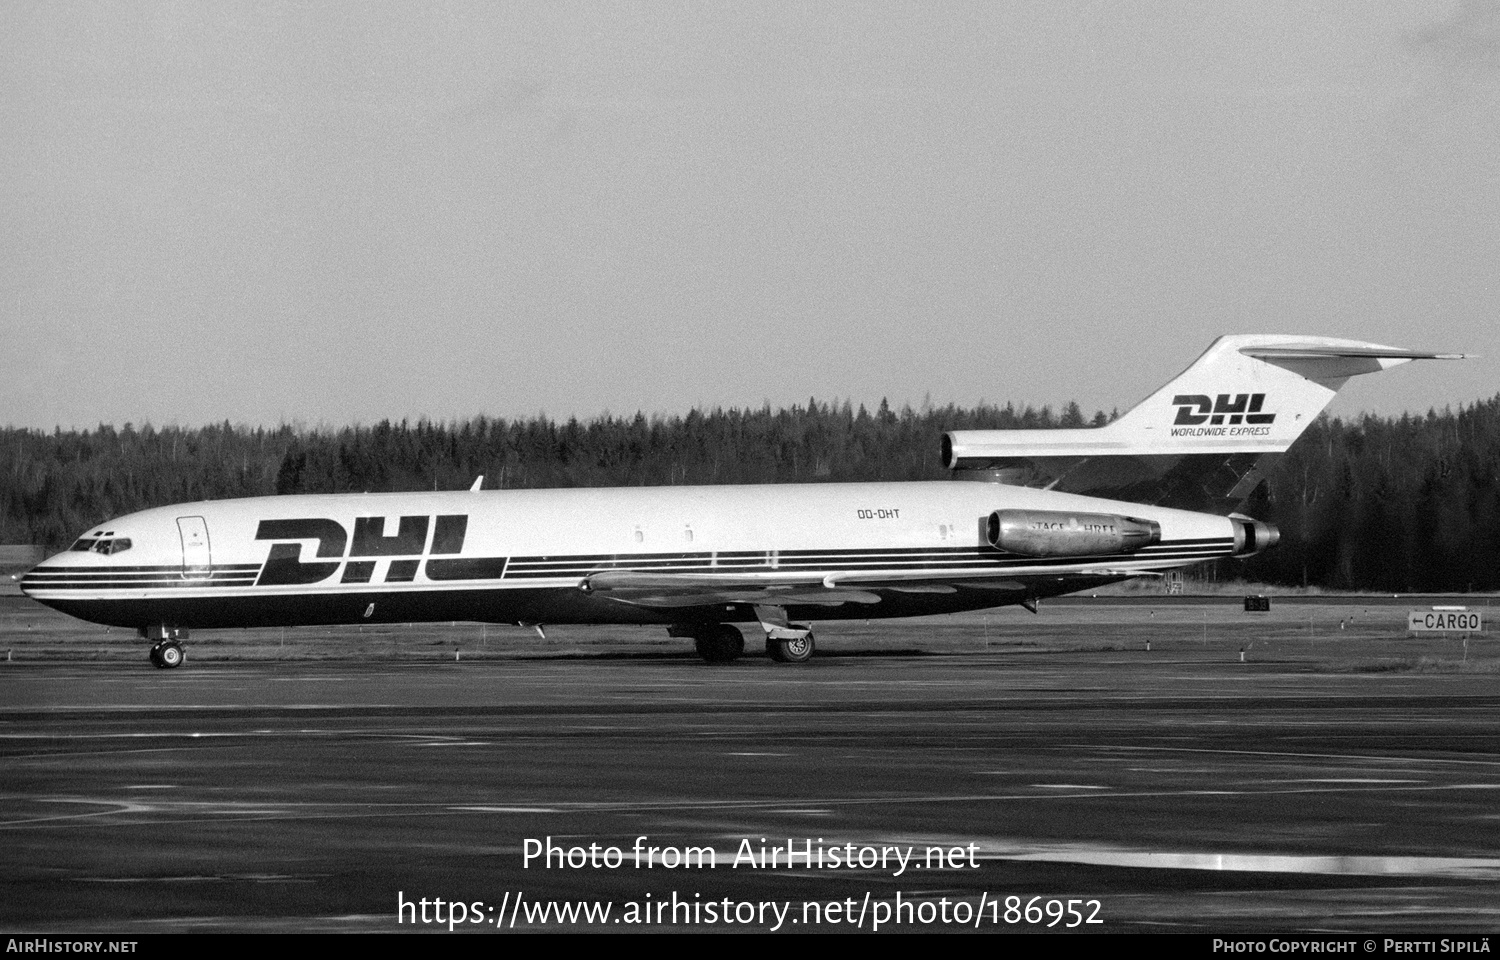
xmin=0 ymin=0 xmax=1500 ymax=429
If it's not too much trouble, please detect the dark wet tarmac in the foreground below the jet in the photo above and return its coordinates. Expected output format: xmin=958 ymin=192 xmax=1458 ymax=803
xmin=0 ymin=600 xmax=1500 ymax=936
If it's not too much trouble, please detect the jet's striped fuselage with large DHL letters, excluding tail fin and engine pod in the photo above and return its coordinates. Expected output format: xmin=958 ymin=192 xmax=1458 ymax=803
xmin=23 ymin=482 xmax=1244 ymax=629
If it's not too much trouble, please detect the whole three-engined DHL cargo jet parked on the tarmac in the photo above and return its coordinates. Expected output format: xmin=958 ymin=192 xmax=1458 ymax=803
xmin=21 ymin=335 xmax=1461 ymax=668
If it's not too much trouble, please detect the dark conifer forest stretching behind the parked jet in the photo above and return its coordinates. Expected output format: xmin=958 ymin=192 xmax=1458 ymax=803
xmin=0 ymin=395 xmax=1500 ymax=593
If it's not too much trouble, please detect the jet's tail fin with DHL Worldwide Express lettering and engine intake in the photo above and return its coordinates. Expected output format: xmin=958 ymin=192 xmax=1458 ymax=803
xmin=942 ymin=335 xmax=1464 ymax=513
